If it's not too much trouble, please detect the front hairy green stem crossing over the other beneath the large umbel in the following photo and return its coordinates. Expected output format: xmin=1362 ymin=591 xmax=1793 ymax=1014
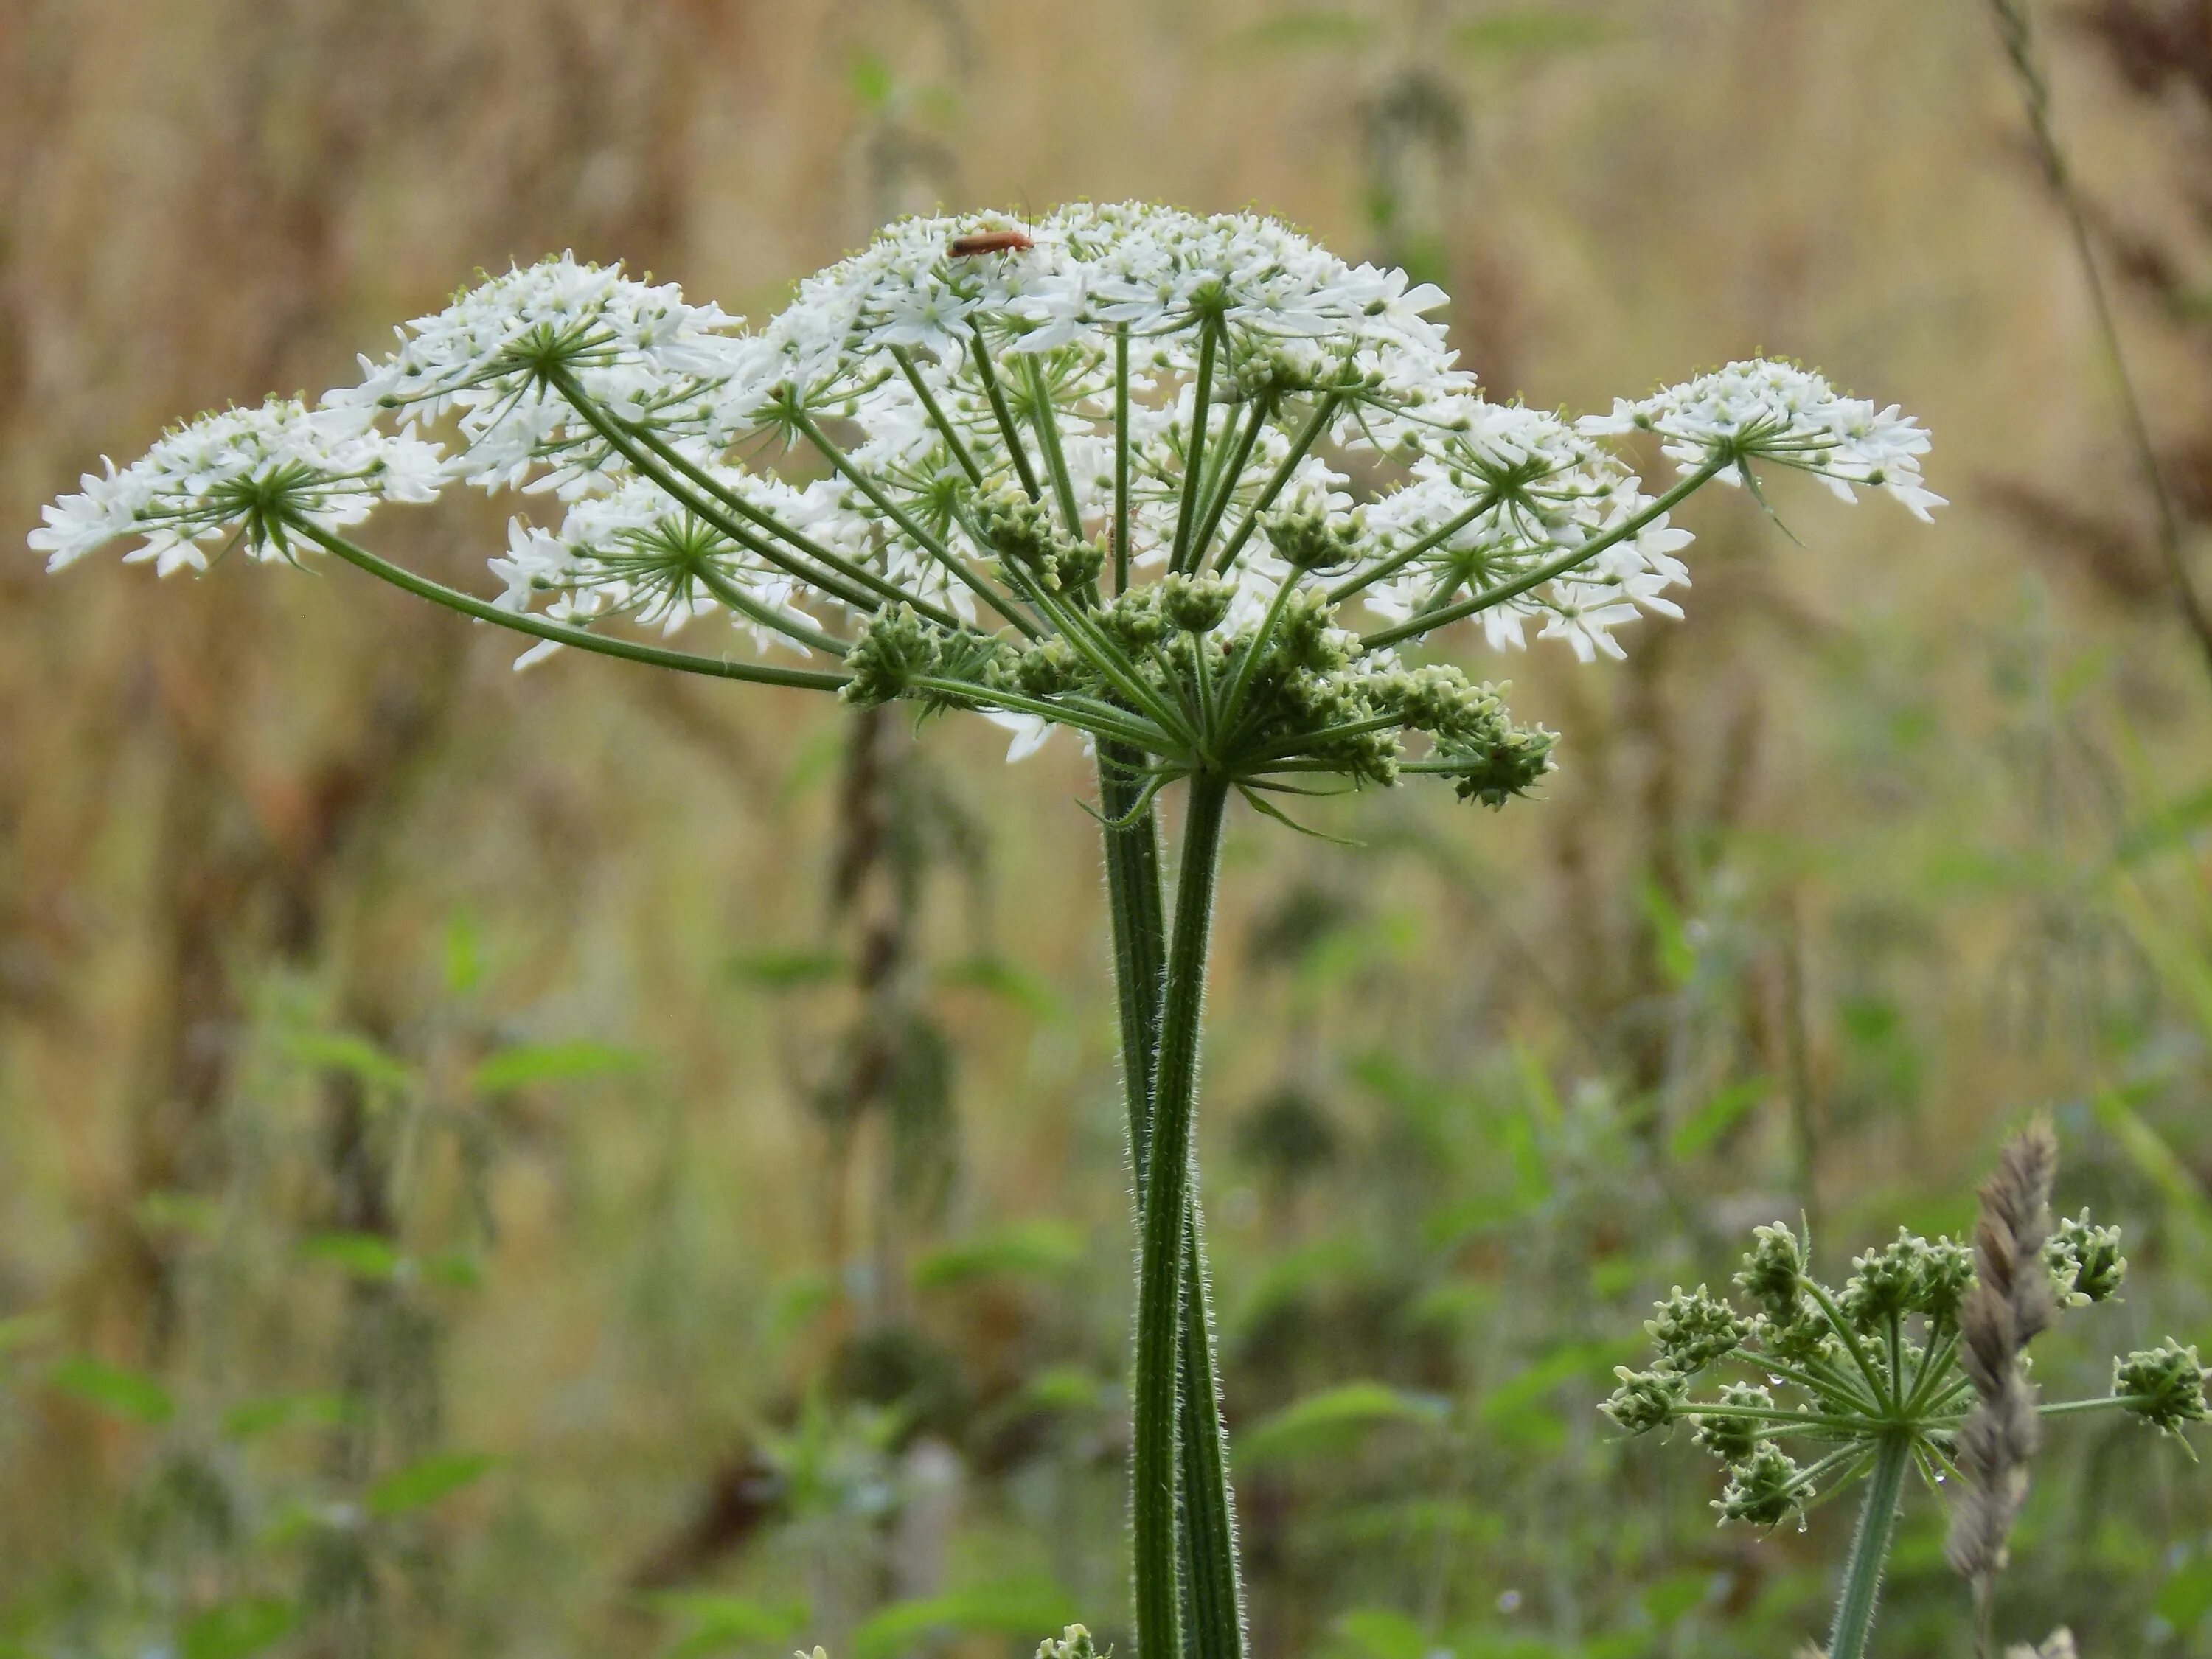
xmin=1130 ymin=772 xmax=1234 ymax=1659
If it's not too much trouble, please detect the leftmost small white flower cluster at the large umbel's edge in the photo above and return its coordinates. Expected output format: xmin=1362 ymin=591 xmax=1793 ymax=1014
xmin=31 ymin=398 xmax=445 ymax=575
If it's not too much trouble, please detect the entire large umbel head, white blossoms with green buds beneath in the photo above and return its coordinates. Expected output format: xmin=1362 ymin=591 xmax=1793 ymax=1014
xmin=31 ymin=204 xmax=1940 ymax=812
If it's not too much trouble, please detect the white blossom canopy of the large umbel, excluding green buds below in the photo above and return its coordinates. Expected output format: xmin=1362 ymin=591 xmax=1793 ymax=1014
xmin=33 ymin=204 xmax=1942 ymax=717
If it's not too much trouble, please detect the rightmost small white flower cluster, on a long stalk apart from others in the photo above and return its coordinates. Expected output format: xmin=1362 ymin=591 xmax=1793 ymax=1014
xmin=1582 ymin=358 xmax=1944 ymax=522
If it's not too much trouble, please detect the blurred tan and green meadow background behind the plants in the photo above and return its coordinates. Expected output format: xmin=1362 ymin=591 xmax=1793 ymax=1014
xmin=0 ymin=0 xmax=2212 ymax=1659
